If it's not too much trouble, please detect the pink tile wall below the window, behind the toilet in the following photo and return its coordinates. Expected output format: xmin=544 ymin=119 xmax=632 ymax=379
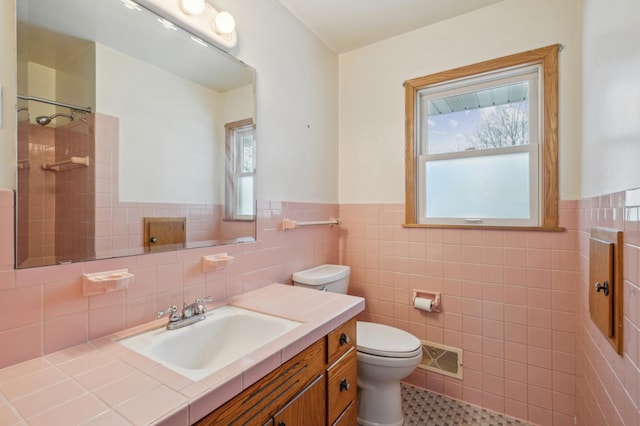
xmin=339 ymin=201 xmax=578 ymax=425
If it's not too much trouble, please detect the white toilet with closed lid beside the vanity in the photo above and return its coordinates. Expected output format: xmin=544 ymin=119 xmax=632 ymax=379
xmin=293 ymin=265 xmax=422 ymax=426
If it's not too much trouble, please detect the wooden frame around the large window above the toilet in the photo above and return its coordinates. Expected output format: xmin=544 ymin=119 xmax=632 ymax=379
xmin=403 ymin=44 xmax=563 ymax=231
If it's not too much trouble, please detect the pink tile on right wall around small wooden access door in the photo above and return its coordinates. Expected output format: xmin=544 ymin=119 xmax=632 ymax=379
xmin=576 ymin=189 xmax=640 ymax=426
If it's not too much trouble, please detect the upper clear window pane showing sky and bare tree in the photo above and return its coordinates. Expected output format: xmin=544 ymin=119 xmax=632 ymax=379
xmin=423 ymin=81 xmax=529 ymax=154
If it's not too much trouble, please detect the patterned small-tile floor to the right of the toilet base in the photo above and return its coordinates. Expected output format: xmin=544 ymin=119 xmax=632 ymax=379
xmin=402 ymin=383 xmax=529 ymax=426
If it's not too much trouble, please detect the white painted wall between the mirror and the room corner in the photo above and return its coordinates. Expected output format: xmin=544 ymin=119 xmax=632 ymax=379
xmin=215 ymin=0 xmax=338 ymax=203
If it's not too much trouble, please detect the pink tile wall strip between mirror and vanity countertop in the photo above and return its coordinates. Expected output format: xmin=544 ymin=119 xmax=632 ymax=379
xmin=0 ymin=189 xmax=339 ymax=368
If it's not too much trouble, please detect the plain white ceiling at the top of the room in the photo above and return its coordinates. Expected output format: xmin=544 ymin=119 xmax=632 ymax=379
xmin=279 ymin=0 xmax=502 ymax=54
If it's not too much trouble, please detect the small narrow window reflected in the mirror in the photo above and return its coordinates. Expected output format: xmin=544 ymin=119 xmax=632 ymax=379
xmin=224 ymin=118 xmax=256 ymax=220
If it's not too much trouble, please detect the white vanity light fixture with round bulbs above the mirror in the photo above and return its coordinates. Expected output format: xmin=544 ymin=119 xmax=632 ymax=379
xmin=135 ymin=0 xmax=238 ymax=50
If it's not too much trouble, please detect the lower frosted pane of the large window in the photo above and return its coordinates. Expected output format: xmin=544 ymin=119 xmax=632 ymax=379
xmin=425 ymin=152 xmax=530 ymax=219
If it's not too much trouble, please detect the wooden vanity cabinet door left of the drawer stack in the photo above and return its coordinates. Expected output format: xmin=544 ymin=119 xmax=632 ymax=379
xmin=273 ymin=376 xmax=326 ymax=426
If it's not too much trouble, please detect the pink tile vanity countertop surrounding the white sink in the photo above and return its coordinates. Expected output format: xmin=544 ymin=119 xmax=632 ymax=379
xmin=0 ymin=284 xmax=364 ymax=426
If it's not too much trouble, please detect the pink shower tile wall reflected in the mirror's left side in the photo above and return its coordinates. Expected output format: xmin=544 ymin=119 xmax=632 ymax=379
xmin=18 ymin=121 xmax=95 ymax=267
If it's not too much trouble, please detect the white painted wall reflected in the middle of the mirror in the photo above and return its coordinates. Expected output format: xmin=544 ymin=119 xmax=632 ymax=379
xmin=96 ymin=44 xmax=225 ymax=204
